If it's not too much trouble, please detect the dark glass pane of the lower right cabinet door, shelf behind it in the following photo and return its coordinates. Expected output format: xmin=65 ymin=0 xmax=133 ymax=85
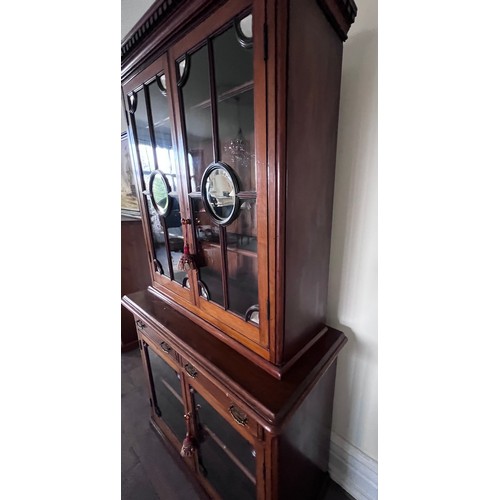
xmin=190 ymin=388 xmax=257 ymax=500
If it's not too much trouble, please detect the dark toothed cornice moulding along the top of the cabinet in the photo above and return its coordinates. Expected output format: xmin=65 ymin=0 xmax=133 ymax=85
xmin=121 ymin=0 xmax=358 ymax=80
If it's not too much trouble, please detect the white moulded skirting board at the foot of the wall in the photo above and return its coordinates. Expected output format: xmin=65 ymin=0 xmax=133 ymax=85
xmin=328 ymin=433 xmax=378 ymax=500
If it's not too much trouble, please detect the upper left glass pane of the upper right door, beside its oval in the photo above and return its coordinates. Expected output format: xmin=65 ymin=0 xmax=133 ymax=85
xmin=181 ymin=45 xmax=214 ymax=192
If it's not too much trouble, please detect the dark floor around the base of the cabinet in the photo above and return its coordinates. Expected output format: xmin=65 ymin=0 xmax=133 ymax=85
xmin=122 ymin=349 xmax=354 ymax=500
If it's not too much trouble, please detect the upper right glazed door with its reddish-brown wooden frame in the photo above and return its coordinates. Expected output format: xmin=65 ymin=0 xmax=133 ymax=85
xmin=169 ymin=1 xmax=268 ymax=347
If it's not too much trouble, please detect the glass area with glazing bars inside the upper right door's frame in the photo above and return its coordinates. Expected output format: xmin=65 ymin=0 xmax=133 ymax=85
xmin=176 ymin=11 xmax=259 ymax=326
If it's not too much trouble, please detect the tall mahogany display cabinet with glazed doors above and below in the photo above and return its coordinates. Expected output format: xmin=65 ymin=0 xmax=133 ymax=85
xmin=122 ymin=0 xmax=357 ymax=500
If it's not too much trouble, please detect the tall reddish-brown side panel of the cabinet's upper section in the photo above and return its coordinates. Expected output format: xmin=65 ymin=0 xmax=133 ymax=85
xmin=283 ymin=0 xmax=342 ymax=361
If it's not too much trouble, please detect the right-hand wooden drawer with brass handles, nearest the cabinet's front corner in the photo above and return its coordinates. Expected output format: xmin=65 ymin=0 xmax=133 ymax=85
xmin=180 ymin=356 xmax=260 ymax=441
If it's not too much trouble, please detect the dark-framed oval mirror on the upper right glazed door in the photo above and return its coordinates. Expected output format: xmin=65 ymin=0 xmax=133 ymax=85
xmin=201 ymin=162 xmax=240 ymax=226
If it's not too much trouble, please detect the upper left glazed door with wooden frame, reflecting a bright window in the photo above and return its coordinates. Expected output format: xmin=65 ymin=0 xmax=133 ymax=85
xmin=123 ymin=58 xmax=193 ymax=302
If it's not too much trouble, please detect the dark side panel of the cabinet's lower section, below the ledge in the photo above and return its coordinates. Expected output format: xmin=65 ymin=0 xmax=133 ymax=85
xmin=278 ymin=361 xmax=337 ymax=500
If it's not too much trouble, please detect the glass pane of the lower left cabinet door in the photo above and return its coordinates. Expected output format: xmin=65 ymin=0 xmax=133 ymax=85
xmin=146 ymin=349 xmax=186 ymax=442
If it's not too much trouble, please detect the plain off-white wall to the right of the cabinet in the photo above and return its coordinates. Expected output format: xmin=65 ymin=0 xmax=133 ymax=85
xmin=328 ymin=0 xmax=378 ymax=484
